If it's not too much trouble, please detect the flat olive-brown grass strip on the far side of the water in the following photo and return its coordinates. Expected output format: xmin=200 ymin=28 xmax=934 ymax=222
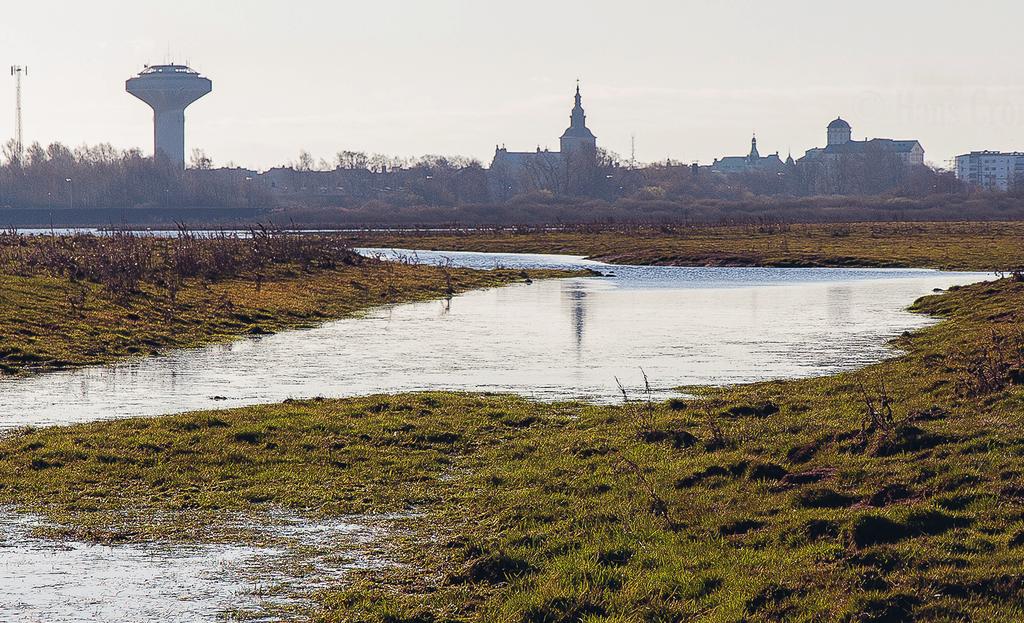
xmin=339 ymin=222 xmax=1024 ymax=271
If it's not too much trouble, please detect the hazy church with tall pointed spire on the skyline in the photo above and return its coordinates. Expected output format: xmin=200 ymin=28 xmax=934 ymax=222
xmin=488 ymin=85 xmax=597 ymax=198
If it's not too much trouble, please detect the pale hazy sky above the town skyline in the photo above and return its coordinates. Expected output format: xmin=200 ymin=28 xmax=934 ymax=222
xmin=0 ymin=0 xmax=1024 ymax=169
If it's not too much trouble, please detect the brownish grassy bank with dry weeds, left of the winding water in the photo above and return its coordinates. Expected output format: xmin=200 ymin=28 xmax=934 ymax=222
xmin=0 ymin=234 xmax=566 ymax=374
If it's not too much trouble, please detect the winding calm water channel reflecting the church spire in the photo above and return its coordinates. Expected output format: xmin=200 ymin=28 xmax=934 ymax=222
xmin=0 ymin=250 xmax=986 ymax=428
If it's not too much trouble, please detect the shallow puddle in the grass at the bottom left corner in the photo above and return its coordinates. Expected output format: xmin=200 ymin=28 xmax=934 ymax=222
xmin=0 ymin=510 xmax=396 ymax=623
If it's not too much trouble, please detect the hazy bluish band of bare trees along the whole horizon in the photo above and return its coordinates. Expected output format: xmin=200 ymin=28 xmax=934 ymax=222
xmin=0 ymin=142 xmax=991 ymax=215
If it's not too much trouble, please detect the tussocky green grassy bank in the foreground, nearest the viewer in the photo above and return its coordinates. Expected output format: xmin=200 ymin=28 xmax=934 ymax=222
xmin=6 ymin=280 xmax=1024 ymax=622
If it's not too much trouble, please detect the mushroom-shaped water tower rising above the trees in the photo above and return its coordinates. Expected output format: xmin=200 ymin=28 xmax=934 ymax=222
xmin=125 ymin=65 xmax=213 ymax=168
